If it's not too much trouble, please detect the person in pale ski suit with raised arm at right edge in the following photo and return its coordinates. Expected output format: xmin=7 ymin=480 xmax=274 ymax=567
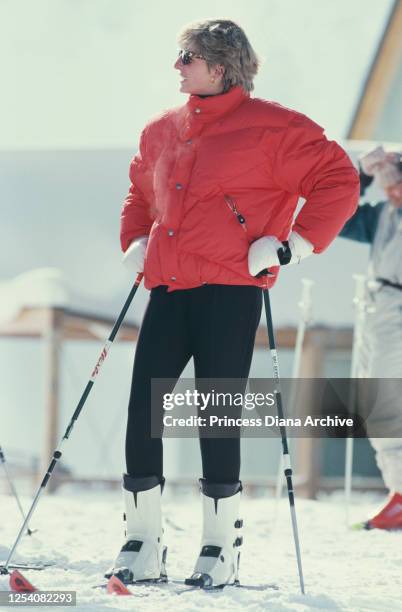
xmin=340 ymin=147 xmax=402 ymax=529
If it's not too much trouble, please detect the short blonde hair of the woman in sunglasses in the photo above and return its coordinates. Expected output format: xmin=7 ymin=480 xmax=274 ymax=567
xmin=179 ymin=19 xmax=260 ymax=92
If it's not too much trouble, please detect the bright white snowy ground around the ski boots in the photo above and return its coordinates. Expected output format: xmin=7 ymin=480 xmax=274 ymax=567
xmin=0 ymin=489 xmax=402 ymax=612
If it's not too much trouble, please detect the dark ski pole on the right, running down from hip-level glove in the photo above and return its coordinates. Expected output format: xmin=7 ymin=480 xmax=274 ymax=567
xmin=263 ymin=289 xmax=305 ymax=595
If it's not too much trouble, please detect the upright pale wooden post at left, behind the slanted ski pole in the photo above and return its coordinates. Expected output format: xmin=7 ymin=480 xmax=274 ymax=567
xmin=41 ymin=308 xmax=64 ymax=493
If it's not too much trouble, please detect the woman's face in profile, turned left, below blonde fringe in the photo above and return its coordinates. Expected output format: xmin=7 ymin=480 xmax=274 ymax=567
xmin=174 ymin=49 xmax=223 ymax=96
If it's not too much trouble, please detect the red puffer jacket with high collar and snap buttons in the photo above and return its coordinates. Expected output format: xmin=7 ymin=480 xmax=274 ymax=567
xmin=121 ymin=87 xmax=359 ymax=291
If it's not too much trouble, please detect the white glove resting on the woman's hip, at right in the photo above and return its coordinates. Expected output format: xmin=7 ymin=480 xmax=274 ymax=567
xmin=248 ymin=232 xmax=314 ymax=276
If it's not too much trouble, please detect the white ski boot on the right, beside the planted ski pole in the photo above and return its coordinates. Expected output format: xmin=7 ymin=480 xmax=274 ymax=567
xmin=185 ymin=479 xmax=243 ymax=589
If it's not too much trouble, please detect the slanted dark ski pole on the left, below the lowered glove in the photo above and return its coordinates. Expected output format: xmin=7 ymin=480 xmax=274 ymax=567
xmin=1 ymin=274 xmax=143 ymax=574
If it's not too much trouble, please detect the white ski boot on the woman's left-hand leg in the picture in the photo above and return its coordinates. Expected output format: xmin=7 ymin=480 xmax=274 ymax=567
xmin=105 ymin=474 xmax=167 ymax=584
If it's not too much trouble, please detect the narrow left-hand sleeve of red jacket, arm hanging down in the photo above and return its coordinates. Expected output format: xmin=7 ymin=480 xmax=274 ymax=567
xmin=120 ymin=129 xmax=153 ymax=251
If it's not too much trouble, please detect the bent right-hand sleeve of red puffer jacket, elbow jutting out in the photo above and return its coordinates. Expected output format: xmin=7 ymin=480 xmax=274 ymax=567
xmin=273 ymin=114 xmax=360 ymax=253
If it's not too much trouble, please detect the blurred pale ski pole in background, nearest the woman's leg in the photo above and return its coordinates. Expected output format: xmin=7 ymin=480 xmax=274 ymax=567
xmin=274 ymin=278 xmax=314 ymax=521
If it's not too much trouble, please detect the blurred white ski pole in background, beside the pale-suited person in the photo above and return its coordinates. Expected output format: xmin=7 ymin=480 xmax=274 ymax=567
xmin=345 ymin=274 xmax=366 ymax=527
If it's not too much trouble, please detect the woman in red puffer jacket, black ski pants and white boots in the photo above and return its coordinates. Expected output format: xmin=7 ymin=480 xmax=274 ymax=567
xmin=108 ymin=20 xmax=359 ymax=586
